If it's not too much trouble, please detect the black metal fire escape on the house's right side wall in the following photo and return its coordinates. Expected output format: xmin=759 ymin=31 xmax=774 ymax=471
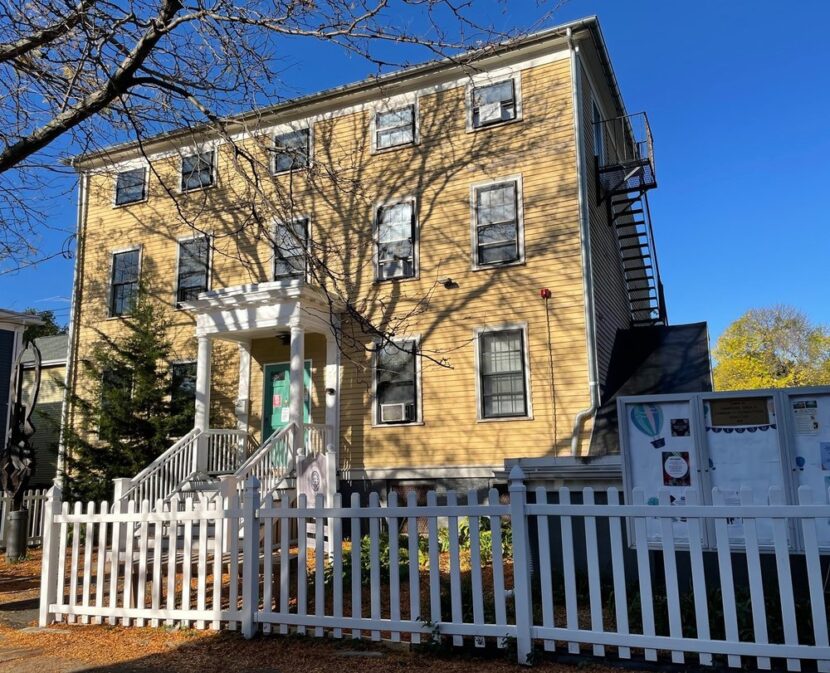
xmin=594 ymin=112 xmax=668 ymax=327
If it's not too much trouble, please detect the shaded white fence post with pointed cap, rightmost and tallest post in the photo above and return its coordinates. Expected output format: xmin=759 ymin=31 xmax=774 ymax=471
xmin=507 ymin=465 xmax=533 ymax=665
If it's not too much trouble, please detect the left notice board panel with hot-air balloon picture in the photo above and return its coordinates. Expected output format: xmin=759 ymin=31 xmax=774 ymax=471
xmin=620 ymin=400 xmax=702 ymax=542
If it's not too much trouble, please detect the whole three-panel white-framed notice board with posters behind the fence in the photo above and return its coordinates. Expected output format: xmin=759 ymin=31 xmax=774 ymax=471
xmin=617 ymin=387 xmax=830 ymax=550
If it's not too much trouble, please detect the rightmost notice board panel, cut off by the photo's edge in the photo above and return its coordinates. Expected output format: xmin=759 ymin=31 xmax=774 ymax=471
xmin=785 ymin=394 xmax=830 ymax=549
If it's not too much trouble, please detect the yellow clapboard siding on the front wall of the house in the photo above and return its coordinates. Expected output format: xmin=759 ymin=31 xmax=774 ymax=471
xmin=70 ymin=55 xmax=588 ymax=468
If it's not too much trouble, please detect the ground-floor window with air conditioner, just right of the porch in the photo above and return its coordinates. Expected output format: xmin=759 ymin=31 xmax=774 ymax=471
xmin=375 ymin=339 xmax=418 ymax=425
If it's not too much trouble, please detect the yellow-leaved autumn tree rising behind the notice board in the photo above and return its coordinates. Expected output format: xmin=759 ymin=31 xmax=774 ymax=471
xmin=713 ymin=306 xmax=830 ymax=390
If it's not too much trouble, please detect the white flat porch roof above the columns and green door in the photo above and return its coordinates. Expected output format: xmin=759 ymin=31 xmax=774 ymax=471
xmin=181 ymin=279 xmax=340 ymax=341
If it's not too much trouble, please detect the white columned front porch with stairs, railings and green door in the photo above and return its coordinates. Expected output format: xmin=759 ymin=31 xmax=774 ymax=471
xmin=116 ymin=280 xmax=340 ymax=503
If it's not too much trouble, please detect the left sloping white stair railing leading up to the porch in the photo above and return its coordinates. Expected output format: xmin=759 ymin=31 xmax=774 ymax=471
xmin=121 ymin=428 xmax=201 ymax=503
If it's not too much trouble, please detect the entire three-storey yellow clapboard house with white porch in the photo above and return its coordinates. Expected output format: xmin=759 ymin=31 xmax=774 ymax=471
xmin=63 ymin=18 xmax=684 ymax=499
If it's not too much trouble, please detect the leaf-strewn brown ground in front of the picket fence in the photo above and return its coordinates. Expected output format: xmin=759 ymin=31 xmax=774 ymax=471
xmin=0 ymin=551 xmax=648 ymax=673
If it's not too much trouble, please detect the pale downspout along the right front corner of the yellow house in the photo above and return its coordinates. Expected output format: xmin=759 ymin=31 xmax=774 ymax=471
xmin=567 ymin=28 xmax=599 ymax=456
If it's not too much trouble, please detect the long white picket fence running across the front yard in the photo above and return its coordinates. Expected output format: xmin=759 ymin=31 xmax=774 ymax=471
xmin=40 ymin=468 xmax=830 ymax=671
